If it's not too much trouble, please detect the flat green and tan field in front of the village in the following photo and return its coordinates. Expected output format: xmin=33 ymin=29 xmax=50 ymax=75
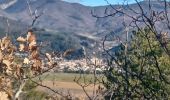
xmin=34 ymin=73 xmax=103 ymax=98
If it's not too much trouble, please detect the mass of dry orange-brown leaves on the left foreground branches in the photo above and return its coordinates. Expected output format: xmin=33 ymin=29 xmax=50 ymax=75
xmin=0 ymin=31 xmax=56 ymax=100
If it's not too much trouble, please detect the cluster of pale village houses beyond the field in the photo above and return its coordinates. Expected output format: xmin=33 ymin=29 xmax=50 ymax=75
xmin=50 ymin=57 xmax=106 ymax=73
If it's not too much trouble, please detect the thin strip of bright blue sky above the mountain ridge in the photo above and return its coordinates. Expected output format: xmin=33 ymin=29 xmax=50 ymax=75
xmin=65 ymin=0 xmax=135 ymax=6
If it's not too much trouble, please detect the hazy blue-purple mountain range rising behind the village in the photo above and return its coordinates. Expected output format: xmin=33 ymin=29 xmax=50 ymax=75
xmin=0 ymin=0 xmax=166 ymax=56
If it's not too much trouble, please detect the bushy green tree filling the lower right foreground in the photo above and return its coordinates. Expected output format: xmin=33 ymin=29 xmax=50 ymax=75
xmin=104 ymin=28 xmax=170 ymax=99
